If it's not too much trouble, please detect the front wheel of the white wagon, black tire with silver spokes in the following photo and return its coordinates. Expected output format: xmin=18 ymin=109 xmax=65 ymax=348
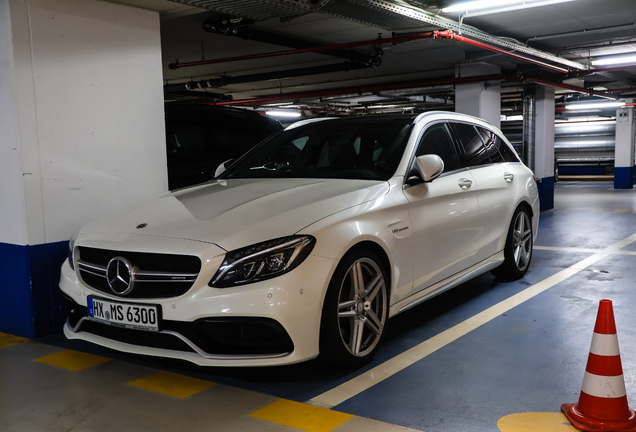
xmin=320 ymin=248 xmax=389 ymax=367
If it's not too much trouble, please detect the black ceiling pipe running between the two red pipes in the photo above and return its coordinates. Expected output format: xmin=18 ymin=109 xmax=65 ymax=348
xmin=163 ymin=62 xmax=371 ymax=93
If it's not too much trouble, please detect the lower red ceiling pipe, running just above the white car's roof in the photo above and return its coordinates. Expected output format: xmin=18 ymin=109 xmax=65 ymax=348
xmin=214 ymin=74 xmax=517 ymax=105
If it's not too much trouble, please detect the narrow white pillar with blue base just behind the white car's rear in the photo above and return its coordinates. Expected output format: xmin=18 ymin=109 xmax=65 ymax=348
xmin=534 ymin=86 xmax=554 ymax=211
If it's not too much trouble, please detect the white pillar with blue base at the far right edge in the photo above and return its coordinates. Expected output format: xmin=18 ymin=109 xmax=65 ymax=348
xmin=614 ymin=104 xmax=634 ymax=189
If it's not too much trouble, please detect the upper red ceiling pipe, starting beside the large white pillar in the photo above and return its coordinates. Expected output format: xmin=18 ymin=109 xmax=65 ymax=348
xmin=168 ymin=32 xmax=435 ymax=69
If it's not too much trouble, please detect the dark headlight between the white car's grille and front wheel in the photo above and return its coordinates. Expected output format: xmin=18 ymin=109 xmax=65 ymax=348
xmin=208 ymin=236 xmax=316 ymax=288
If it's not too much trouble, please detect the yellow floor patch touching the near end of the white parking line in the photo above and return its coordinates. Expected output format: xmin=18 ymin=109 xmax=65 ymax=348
xmin=250 ymin=399 xmax=353 ymax=432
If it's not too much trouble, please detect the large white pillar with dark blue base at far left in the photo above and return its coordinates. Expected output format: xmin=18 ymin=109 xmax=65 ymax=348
xmin=0 ymin=0 xmax=167 ymax=338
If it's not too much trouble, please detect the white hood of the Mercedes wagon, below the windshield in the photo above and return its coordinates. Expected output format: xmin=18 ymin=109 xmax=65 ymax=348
xmin=82 ymin=179 xmax=389 ymax=250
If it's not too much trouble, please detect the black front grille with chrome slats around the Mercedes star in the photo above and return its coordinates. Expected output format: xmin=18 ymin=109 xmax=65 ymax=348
xmin=77 ymin=247 xmax=201 ymax=298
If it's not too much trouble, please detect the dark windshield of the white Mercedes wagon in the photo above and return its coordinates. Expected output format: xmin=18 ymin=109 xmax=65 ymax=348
xmin=222 ymin=118 xmax=412 ymax=180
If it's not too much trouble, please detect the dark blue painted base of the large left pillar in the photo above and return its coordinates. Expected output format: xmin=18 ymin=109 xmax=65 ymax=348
xmin=0 ymin=241 xmax=68 ymax=339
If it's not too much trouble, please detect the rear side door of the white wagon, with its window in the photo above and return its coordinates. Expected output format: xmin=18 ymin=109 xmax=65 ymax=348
xmin=451 ymin=122 xmax=516 ymax=262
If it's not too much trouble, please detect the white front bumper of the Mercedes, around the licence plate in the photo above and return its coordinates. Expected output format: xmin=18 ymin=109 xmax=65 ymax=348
xmin=60 ymin=255 xmax=337 ymax=367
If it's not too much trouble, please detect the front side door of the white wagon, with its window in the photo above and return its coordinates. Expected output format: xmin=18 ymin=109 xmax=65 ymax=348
xmin=404 ymin=122 xmax=479 ymax=292
